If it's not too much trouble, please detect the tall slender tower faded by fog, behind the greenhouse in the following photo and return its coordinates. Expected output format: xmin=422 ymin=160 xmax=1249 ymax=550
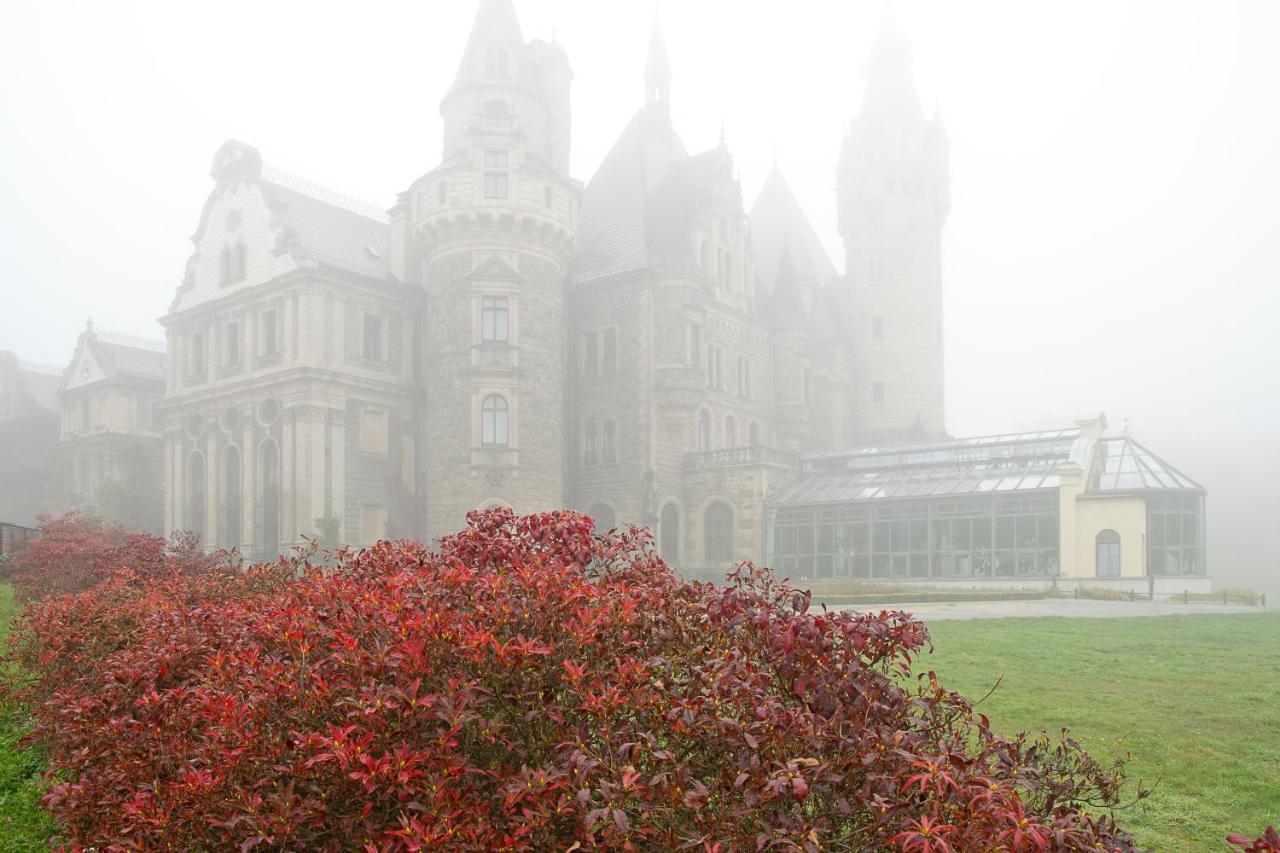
xmin=837 ymin=9 xmax=951 ymax=443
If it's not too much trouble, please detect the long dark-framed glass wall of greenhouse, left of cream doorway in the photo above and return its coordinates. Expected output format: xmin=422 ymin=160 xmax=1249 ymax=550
xmin=765 ymin=492 xmax=1059 ymax=579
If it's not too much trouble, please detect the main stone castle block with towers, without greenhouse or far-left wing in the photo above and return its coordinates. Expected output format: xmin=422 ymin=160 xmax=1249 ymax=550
xmin=137 ymin=0 xmax=946 ymax=573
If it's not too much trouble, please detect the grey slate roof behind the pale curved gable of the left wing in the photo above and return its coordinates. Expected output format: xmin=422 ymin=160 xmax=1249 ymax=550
xmin=261 ymin=177 xmax=390 ymax=279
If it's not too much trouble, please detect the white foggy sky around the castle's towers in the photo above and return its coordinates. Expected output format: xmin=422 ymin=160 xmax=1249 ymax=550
xmin=0 ymin=0 xmax=1280 ymax=594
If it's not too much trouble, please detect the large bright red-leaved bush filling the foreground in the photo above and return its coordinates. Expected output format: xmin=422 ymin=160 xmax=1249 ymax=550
xmin=17 ymin=510 xmax=1133 ymax=850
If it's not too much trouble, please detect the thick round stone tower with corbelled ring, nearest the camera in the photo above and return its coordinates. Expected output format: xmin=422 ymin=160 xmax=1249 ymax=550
xmin=392 ymin=0 xmax=580 ymax=538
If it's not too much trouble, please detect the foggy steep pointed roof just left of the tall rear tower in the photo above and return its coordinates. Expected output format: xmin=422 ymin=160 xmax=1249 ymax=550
xmin=751 ymin=167 xmax=836 ymax=292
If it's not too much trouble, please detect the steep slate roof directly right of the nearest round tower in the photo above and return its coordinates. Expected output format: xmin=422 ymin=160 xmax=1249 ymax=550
xmin=573 ymin=105 xmax=689 ymax=282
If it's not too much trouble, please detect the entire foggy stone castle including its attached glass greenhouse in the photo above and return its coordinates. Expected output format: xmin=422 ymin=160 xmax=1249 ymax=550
xmin=42 ymin=0 xmax=1204 ymax=579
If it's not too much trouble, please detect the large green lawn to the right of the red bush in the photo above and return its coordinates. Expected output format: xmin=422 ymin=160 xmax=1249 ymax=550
xmin=923 ymin=613 xmax=1280 ymax=850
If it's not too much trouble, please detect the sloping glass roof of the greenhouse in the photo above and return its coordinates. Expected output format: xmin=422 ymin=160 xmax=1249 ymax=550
xmin=768 ymin=429 xmax=1199 ymax=506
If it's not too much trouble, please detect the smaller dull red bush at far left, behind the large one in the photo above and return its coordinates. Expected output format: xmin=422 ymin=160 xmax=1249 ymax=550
xmin=3 ymin=512 xmax=220 ymax=601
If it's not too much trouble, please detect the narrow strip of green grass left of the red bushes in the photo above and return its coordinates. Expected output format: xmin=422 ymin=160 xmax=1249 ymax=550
xmin=0 ymin=584 xmax=54 ymax=853
